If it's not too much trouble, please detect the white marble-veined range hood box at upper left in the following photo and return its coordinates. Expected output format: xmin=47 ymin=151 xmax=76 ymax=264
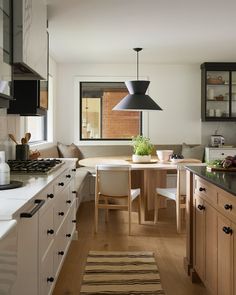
xmin=13 ymin=0 xmax=48 ymax=80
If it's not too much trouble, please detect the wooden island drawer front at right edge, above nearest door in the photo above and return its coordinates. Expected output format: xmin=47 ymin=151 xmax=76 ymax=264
xmin=218 ymin=190 xmax=236 ymax=222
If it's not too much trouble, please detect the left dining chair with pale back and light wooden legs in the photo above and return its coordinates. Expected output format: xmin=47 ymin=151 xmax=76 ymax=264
xmin=95 ymin=164 xmax=141 ymax=235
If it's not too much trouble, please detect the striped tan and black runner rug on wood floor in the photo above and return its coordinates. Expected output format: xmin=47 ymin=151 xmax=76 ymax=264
xmin=80 ymin=251 xmax=165 ymax=295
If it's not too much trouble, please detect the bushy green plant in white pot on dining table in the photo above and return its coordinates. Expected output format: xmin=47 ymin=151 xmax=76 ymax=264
xmin=132 ymin=135 xmax=154 ymax=162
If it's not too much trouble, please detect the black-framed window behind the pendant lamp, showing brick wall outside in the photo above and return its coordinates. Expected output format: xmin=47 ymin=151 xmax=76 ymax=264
xmin=80 ymin=82 xmax=142 ymax=140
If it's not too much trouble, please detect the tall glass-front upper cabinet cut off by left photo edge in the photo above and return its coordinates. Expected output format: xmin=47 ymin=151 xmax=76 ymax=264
xmin=0 ymin=0 xmax=12 ymax=108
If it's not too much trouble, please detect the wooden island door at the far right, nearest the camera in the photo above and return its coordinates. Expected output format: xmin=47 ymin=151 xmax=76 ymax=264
xmin=218 ymin=214 xmax=233 ymax=295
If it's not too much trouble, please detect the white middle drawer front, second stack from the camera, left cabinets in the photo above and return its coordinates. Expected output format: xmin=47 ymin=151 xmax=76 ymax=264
xmin=54 ymin=186 xmax=69 ymax=231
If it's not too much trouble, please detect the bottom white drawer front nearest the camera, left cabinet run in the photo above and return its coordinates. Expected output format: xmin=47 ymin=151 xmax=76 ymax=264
xmin=39 ymin=247 xmax=55 ymax=295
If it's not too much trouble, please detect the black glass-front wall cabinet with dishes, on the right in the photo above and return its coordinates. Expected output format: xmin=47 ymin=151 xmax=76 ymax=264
xmin=201 ymin=62 xmax=236 ymax=121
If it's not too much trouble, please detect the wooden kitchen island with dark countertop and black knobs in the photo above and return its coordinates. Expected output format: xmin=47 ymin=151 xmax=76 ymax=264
xmin=184 ymin=166 xmax=236 ymax=295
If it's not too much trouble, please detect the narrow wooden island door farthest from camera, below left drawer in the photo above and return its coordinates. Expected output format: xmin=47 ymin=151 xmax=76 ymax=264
xmin=194 ymin=196 xmax=205 ymax=281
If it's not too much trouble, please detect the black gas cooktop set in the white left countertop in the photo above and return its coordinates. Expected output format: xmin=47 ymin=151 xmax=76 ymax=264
xmin=7 ymin=159 xmax=64 ymax=174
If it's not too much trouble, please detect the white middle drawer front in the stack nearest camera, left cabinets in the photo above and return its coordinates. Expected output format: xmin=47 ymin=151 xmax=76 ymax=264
xmin=39 ymin=202 xmax=55 ymax=259
